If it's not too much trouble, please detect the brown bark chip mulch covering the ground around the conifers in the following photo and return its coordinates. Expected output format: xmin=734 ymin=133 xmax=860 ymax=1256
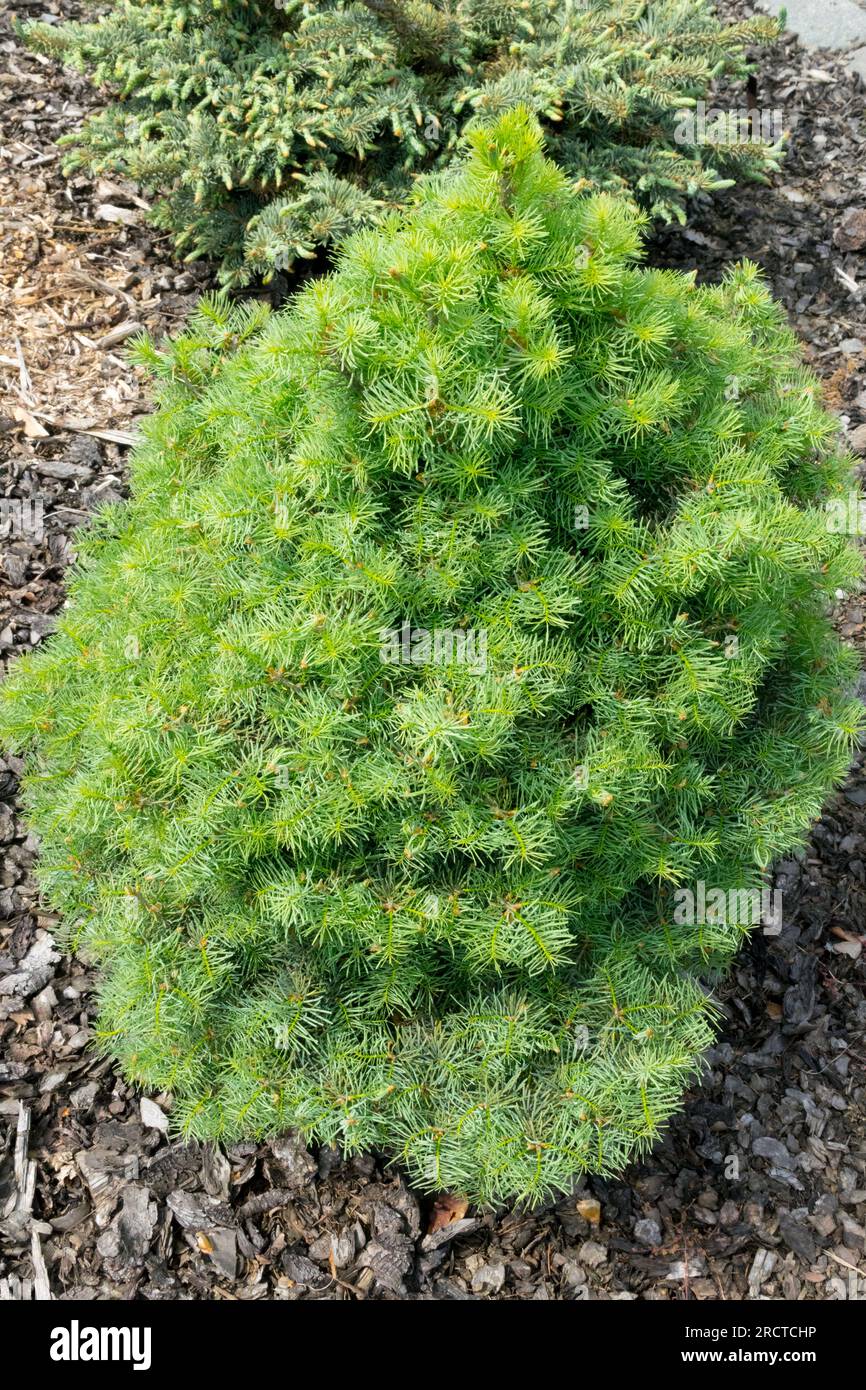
xmin=0 ymin=0 xmax=866 ymax=1301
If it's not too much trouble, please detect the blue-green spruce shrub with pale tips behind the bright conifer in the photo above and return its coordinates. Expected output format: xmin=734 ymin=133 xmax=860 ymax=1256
xmin=25 ymin=0 xmax=780 ymax=284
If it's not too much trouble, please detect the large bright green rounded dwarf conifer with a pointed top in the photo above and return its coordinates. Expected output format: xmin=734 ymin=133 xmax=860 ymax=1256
xmin=0 ymin=110 xmax=862 ymax=1202
